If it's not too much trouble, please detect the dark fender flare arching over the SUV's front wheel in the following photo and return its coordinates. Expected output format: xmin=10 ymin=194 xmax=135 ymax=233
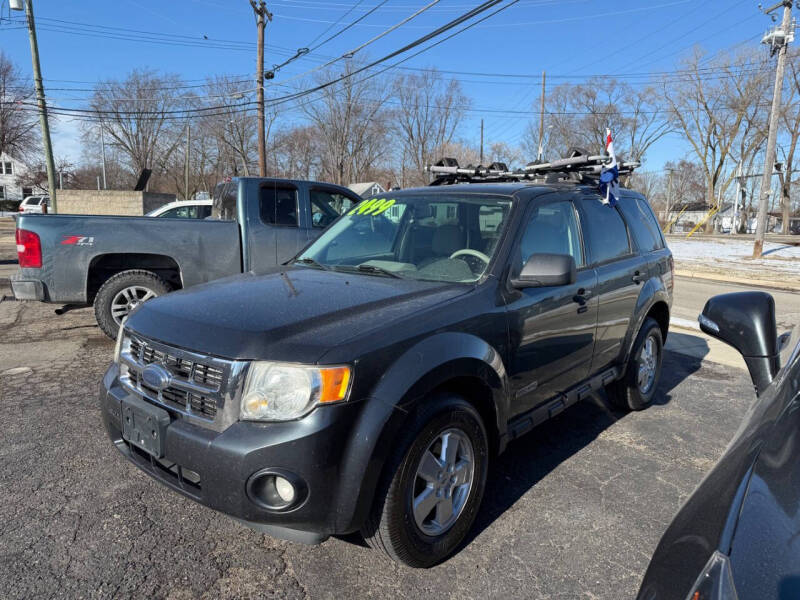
xmin=334 ymin=332 xmax=510 ymax=532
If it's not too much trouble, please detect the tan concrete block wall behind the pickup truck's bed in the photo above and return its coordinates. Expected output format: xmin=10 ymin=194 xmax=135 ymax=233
xmin=57 ymin=190 xmax=175 ymax=216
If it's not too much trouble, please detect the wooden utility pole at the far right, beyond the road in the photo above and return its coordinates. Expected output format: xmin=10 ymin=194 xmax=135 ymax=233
xmin=753 ymin=0 xmax=794 ymax=258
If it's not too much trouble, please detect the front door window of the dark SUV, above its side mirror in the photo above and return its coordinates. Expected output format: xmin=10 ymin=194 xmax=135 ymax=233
xmin=511 ymin=200 xmax=584 ymax=275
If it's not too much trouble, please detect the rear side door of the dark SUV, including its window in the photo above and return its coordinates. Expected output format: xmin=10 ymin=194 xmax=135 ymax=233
xmin=577 ymin=194 xmax=648 ymax=372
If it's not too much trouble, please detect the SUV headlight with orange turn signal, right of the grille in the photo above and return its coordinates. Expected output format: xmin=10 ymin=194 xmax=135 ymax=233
xmin=239 ymin=361 xmax=350 ymax=421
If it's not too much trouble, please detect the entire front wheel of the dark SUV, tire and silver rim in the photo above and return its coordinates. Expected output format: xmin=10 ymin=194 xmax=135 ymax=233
xmin=361 ymin=395 xmax=489 ymax=567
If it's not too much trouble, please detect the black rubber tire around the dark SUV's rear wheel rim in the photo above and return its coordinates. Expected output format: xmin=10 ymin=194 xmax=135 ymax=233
xmin=606 ymin=317 xmax=664 ymax=410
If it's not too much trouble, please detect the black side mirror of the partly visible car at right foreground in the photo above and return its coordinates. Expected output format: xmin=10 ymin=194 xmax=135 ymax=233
xmin=697 ymin=292 xmax=780 ymax=394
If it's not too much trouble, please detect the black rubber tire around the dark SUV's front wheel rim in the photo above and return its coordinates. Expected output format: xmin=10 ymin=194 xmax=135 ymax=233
xmin=361 ymin=394 xmax=489 ymax=568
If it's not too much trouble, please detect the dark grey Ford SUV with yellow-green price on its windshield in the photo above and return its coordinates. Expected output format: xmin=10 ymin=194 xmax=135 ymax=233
xmin=100 ymin=177 xmax=673 ymax=567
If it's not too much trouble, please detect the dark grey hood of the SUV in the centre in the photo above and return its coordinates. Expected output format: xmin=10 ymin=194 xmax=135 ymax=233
xmin=126 ymin=267 xmax=472 ymax=363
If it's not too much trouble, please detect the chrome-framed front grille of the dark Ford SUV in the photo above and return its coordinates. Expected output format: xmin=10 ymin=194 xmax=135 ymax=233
xmin=120 ymin=332 xmax=244 ymax=429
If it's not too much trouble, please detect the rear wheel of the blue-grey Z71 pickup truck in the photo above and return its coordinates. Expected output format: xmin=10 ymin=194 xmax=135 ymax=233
xmin=94 ymin=269 xmax=170 ymax=339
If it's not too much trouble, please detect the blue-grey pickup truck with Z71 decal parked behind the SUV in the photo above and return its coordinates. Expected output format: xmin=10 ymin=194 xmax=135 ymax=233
xmin=11 ymin=177 xmax=361 ymax=337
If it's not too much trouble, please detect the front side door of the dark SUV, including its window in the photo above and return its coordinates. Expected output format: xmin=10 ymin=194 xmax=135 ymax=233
xmin=508 ymin=194 xmax=597 ymax=414
